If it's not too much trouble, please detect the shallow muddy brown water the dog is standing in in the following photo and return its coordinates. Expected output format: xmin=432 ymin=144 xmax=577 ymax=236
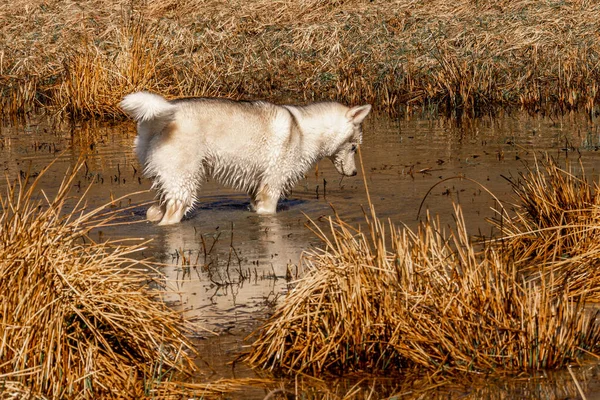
xmin=0 ymin=115 xmax=600 ymax=398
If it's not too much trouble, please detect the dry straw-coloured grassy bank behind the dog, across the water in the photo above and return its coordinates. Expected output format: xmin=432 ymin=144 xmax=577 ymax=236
xmin=0 ymin=0 xmax=600 ymax=118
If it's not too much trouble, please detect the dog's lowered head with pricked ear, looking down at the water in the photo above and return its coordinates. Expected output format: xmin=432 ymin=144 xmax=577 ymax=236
xmin=329 ymin=104 xmax=371 ymax=176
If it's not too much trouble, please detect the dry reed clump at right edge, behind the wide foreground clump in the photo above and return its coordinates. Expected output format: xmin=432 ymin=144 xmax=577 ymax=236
xmin=492 ymin=155 xmax=600 ymax=301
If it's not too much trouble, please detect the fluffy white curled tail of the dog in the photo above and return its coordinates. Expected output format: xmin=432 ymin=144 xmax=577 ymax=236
xmin=120 ymin=92 xmax=177 ymax=122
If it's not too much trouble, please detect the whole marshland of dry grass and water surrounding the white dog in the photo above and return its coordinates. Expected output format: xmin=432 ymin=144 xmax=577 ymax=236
xmin=0 ymin=0 xmax=600 ymax=399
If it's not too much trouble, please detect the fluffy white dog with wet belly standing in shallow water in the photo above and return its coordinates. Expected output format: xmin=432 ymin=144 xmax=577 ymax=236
xmin=121 ymin=92 xmax=371 ymax=225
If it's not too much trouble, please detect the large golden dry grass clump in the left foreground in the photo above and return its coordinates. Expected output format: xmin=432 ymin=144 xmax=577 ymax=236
xmin=0 ymin=165 xmax=270 ymax=399
